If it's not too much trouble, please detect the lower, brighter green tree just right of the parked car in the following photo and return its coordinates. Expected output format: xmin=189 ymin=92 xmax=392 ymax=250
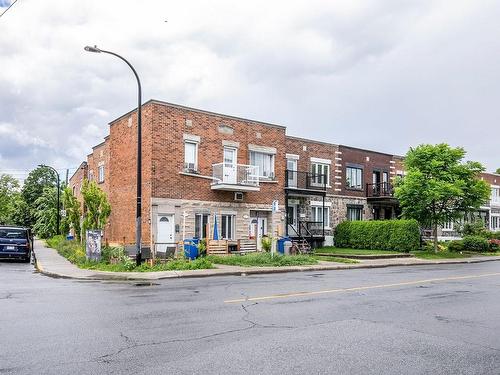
xmin=33 ymin=186 xmax=57 ymax=238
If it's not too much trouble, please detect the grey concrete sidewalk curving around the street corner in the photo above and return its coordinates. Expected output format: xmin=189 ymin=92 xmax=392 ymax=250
xmin=35 ymin=241 xmax=500 ymax=280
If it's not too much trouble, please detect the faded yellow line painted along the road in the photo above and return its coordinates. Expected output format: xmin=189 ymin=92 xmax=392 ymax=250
xmin=224 ymin=272 xmax=500 ymax=303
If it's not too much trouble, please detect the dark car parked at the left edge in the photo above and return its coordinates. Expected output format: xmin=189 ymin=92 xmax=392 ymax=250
xmin=0 ymin=226 xmax=33 ymax=262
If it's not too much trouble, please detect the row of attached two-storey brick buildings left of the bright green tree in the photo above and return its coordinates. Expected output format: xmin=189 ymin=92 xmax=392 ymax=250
xmin=70 ymin=100 xmax=496 ymax=252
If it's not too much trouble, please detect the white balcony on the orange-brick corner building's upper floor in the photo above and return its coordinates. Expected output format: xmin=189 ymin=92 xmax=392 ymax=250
xmin=211 ymin=163 xmax=260 ymax=191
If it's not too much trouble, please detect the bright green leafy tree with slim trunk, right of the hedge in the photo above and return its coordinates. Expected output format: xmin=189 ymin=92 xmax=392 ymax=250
xmin=395 ymin=143 xmax=490 ymax=251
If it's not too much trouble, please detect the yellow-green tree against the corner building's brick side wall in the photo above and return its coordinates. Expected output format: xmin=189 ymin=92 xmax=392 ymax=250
xmin=82 ymin=180 xmax=111 ymax=231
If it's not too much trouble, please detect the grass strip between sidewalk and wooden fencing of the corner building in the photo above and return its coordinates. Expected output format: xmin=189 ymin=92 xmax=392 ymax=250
xmin=206 ymin=253 xmax=318 ymax=267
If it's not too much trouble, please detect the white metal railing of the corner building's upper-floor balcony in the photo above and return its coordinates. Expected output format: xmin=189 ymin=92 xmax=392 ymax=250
xmin=212 ymin=163 xmax=259 ymax=187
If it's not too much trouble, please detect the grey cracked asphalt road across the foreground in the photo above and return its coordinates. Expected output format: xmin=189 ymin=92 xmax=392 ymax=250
xmin=0 ymin=254 xmax=500 ymax=375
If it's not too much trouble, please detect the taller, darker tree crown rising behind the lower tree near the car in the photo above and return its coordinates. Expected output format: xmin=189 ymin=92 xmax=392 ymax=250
xmin=21 ymin=167 xmax=57 ymax=226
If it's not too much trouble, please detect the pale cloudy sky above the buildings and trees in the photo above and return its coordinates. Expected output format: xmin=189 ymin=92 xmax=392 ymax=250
xmin=0 ymin=0 xmax=500 ymax=182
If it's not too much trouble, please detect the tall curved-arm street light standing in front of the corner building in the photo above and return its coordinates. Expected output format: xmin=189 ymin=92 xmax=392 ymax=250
xmin=84 ymin=46 xmax=142 ymax=265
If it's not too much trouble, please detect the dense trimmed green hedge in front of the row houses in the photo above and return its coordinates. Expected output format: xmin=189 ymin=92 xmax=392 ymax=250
xmin=334 ymin=220 xmax=420 ymax=252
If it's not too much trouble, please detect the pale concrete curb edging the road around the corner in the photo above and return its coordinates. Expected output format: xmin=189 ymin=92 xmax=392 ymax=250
xmin=35 ymin=257 xmax=500 ymax=281
